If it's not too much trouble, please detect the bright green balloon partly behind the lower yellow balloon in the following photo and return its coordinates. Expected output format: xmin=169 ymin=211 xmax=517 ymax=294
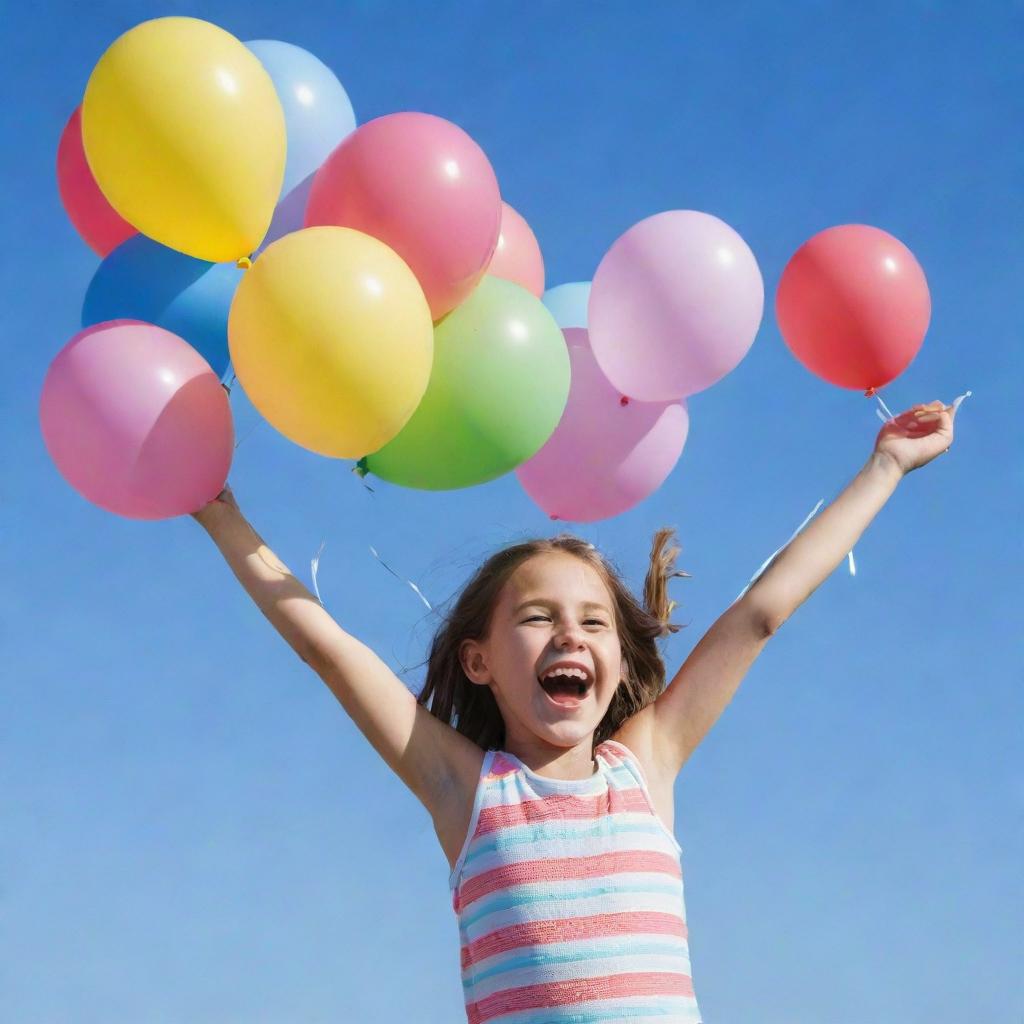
xmin=357 ymin=276 xmax=569 ymax=490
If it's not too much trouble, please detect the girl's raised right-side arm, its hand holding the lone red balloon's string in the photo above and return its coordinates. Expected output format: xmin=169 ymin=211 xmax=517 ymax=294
xmin=650 ymin=401 xmax=955 ymax=778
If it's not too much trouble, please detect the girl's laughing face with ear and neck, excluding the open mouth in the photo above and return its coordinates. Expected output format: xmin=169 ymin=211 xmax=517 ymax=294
xmin=460 ymin=552 xmax=625 ymax=757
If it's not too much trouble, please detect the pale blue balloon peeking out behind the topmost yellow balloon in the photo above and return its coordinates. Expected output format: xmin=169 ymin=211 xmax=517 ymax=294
xmin=246 ymin=39 xmax=355 ymax=196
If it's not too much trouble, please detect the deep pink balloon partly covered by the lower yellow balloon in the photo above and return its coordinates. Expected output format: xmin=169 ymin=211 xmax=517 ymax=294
xmin=305 ymin=113 xmax=502 ymax=321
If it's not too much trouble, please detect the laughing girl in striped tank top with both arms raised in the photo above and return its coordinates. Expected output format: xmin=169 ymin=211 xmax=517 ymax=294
xmin=195 ymin=401 xmax=955 ymax=1024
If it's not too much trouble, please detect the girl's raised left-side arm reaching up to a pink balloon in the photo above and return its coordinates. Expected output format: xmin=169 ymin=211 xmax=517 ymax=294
xmin=195 ymin=489 xmax=478 ymax=818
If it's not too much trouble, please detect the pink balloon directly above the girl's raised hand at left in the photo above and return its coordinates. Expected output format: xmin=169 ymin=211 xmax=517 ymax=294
xmin=39 ymin=319 xmax=234 ymax=519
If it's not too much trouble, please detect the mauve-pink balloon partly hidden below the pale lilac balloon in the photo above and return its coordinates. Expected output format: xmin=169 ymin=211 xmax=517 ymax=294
xmin=516 ymin=328 xmax=689 ymax=522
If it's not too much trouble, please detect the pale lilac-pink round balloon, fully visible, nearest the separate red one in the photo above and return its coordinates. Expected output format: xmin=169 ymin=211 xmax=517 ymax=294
xmin=588 ymin=210 xmax=765 ymax=401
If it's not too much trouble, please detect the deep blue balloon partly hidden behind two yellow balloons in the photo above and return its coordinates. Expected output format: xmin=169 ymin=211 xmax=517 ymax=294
xmin=82 ymin=234 xmax=245 ymax=377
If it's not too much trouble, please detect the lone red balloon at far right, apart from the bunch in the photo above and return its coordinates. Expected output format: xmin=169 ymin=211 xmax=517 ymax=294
xmin=775 ymin=224 xmax=932 ymax=390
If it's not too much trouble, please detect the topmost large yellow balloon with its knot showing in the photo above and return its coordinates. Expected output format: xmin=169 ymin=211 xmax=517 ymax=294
xmin=82 ymin=17 xmax=287 ymax=263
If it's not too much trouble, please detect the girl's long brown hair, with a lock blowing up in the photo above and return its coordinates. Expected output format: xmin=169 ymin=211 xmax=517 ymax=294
xmin=417 ymin=528 xmax=689 ymax=751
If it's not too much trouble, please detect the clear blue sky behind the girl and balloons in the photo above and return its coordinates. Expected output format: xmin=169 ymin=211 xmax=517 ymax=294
xmin=0 ymin=0 xmax=1024 ymax=1024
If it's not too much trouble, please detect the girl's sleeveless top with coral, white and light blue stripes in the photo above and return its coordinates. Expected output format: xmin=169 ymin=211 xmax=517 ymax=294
xmin=450 ymin=739 xmax=700 ymax=1024
